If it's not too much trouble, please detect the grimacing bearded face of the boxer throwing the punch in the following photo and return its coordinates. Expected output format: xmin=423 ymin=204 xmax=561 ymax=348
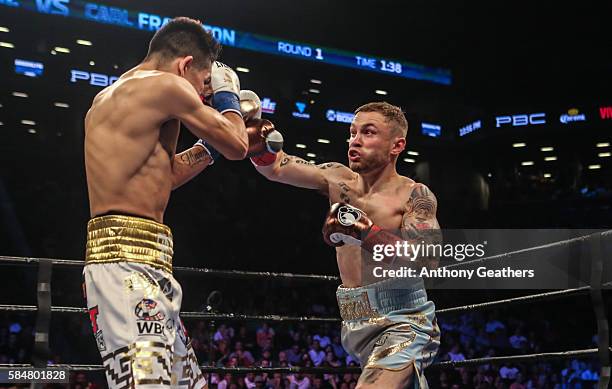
xmin=348 ymin=112 xmax=399 ymax=173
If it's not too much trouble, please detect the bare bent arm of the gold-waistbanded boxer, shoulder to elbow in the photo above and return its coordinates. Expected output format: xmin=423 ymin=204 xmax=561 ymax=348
xmin=163 ymin=76 xmax=249 ymax=160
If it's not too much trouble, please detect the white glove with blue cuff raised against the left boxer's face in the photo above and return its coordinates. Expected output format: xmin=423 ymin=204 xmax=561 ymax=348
xmin=210 ymin=61 xmax=242 ymax=115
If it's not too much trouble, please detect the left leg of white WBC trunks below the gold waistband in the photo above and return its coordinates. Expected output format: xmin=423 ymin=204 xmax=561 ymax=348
xmin=84 ymin=262 xmax=180 ymax=388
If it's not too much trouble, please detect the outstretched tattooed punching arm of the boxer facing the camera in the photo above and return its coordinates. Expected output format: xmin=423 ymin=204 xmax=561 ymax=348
xmin=255 ymin=151 xmax=352 ymax=194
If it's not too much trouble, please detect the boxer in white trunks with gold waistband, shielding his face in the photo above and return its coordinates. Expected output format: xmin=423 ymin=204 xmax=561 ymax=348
xmin=83 ymin=17 xmax=248 ymax=389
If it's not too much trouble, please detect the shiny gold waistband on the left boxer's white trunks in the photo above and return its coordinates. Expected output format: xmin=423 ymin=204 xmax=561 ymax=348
xmin=85 ymin=215 xmax=173 ymax=273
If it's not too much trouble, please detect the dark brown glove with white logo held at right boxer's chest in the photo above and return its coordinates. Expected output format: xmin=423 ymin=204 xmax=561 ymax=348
xmin=323 ymin=203 xmax=374 ymax=247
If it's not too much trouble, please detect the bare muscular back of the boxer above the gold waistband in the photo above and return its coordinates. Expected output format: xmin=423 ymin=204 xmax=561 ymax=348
xmin=85 ymin=70 xmax=179 ymax=222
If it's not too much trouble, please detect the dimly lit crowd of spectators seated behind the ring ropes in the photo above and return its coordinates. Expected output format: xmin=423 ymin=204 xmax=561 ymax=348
xmin=0 ymin=290 xmax=599 ymax=389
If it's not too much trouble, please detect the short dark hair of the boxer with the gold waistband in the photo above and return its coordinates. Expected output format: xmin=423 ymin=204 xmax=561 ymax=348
xmin=146 ymin=16 xmax=221 ymax=69
